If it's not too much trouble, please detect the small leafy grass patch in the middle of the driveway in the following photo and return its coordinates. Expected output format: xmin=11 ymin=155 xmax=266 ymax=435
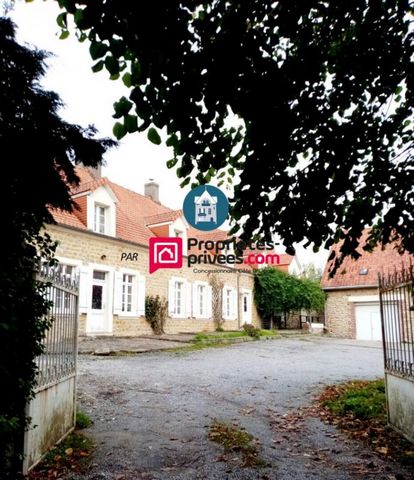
xmin=208 ymin=420 xmax=267 ymax=467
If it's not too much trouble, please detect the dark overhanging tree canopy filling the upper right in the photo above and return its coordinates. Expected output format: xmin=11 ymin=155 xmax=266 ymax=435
xmin=58 ymin=0 xmax=414 ymax=262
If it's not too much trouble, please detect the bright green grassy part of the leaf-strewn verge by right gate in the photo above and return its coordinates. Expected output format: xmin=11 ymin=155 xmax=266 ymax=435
xmin=325 ymin=380 xmax=386 ymax=420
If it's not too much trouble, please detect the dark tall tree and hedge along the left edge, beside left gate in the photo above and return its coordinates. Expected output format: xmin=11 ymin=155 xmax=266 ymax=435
xmin=0 ymin=18 xmax=113 ymax=480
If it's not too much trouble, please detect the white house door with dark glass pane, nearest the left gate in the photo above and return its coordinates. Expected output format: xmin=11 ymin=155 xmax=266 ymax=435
xmin=88 ymin=270 xmax=110 ymax=333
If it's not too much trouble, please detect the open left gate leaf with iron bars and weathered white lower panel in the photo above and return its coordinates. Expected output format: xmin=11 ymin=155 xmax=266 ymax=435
xmin=23 ymin=266 xmax=78 ymax=473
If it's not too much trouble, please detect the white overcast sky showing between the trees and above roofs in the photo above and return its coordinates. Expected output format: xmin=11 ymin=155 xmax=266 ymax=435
xmin=10 ymin=0 xmax=327 ymax=267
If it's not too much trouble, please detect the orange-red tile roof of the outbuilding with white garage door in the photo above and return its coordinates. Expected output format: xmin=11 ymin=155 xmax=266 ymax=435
xmin=321 ymin=229 xmax=414 ymax=289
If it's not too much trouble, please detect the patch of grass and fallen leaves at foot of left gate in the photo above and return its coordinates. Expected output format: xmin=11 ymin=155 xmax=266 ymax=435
xmin=29 ymin=432 xmax=93 ymax=480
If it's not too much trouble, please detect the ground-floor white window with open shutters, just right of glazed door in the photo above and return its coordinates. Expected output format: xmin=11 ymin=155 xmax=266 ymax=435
xmin=114 ymin=269 xmax=145 ymax=317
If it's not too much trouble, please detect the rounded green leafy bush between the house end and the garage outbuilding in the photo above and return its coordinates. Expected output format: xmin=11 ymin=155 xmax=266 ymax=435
xmin=254 ymin=267 xmax=325 ymax=318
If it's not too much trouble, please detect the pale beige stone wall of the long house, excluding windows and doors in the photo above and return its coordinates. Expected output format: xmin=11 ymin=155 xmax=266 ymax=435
xmin=47 ymin=225 xmax=260 ymax=336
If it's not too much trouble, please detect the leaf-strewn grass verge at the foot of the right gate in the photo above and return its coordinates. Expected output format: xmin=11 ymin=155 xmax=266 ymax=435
xmin=318 ymin=380 xmax=414 ymax=466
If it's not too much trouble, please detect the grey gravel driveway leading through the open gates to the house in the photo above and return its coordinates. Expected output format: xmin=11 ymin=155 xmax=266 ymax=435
xmin=71 ymin=337 xmax=414 ymax=480
